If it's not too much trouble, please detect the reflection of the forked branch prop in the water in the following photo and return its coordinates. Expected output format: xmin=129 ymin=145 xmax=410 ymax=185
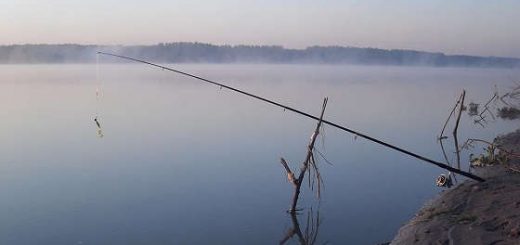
xmin=279 ymin=207 xmax=327 ymax=245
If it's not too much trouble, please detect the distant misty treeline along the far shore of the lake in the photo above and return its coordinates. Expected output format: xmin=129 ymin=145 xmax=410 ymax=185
xmin=0 ymin=42 xmax=520 ymax=68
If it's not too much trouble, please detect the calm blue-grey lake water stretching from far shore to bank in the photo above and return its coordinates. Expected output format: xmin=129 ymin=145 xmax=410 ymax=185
xmin=0 ymin=64 xmax=520 ymax=244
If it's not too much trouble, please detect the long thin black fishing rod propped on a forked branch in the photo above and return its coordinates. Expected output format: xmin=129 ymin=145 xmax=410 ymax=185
xmin=97 ymin=52 xmax=485 ymax=182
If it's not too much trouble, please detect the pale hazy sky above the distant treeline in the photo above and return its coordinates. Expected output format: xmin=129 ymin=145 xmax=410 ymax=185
xmin=0 ymin=0 xmax=520 ymax=57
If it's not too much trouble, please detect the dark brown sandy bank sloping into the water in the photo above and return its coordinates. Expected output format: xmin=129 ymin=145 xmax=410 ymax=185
xmin=391 ymin=130 xmax=520 ymax=245
